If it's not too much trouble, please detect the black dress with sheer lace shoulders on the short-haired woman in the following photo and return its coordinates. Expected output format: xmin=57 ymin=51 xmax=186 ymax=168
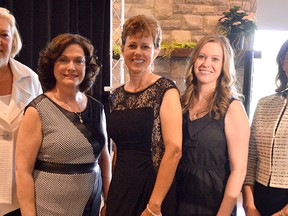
xmin=107 ymin=77 xmax=176 ymax=216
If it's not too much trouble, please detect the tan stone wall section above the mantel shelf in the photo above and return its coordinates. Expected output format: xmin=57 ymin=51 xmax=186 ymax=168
xmin=114 ymin=0 xmax=257 ymax=42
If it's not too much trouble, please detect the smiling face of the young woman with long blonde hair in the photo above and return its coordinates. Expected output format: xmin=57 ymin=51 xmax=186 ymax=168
xmin=194 ymin=42 xmax=223 ymax=88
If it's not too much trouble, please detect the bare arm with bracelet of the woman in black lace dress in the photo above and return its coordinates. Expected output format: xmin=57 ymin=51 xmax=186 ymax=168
xmin=142 ymin=89 xmax=182 ymax=215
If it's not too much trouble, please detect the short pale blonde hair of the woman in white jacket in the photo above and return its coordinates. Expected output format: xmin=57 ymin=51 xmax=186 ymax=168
xmin=0 ymin=7 xmax=22 ymax=58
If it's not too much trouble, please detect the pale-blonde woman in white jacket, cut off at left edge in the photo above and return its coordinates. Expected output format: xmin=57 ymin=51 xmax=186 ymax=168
xmin=0 ymin=8 xmax=42 ymax=216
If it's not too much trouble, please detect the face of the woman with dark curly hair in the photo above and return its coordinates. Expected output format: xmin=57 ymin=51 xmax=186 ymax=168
xmin=54 ymin=44 xmax=86 ymax=88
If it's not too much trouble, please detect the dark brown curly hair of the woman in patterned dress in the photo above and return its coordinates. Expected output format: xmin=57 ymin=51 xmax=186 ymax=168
xmin=38 ymin=33 xmax=101 ymax=92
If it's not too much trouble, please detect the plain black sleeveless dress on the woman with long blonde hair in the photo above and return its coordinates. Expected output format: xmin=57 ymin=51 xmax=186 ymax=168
xmin=176 ymin=112 xmax=236 ymax=216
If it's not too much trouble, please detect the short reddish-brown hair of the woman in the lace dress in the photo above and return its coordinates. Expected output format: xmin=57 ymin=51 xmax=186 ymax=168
xmin=121 ymin=15 xmax=162 ymax=48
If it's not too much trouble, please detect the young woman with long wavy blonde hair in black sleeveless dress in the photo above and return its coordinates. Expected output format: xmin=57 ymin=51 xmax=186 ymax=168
xmin=177 ymin=35 xmax=250 ymax=216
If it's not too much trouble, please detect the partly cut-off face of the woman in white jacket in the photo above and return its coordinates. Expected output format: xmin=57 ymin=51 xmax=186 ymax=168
xmin=0 ymin=17 xmax=13 ymax=67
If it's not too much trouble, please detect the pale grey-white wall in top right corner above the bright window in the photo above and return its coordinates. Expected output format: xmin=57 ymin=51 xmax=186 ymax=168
xmin=256 ymin=0 xmax=288 ymax=31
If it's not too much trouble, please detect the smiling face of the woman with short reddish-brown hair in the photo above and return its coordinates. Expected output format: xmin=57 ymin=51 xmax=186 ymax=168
xmin=121 ymin=33 xmax=159 ymax=74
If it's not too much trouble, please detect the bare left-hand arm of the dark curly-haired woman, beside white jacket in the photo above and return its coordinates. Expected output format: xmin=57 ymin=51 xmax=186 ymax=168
xmin=15 ymin=107 xmax=42 ymax=216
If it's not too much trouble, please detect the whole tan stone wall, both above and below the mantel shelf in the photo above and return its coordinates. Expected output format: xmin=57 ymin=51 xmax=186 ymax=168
xmin=113 ymin=0 xmax=257 ymax=91
